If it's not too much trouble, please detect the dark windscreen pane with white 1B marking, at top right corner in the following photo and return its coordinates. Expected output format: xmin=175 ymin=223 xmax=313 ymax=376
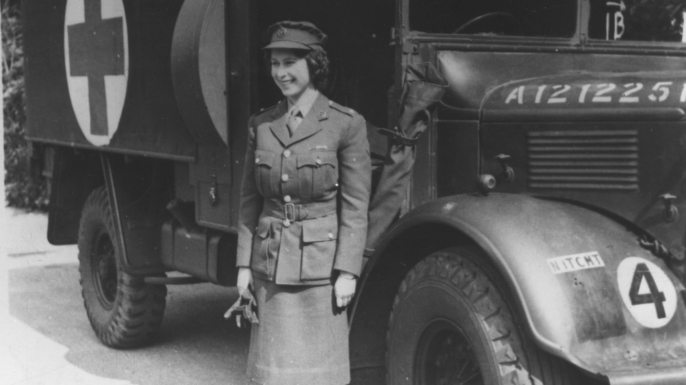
xmin=589 ymin=0 xmax=686 ymax=43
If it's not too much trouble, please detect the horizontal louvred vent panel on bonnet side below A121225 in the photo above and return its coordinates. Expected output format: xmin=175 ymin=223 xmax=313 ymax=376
xmin=527 ymin=130 xmax=638 ymax=191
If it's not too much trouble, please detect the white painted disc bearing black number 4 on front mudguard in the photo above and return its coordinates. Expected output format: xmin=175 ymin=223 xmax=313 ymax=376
xmin=617 ymin=257 xmax=677 ymax=329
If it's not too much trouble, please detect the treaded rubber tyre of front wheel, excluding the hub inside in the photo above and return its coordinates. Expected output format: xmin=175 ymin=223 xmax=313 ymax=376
xmin=386 ymin=247 xmax=577 ymax=385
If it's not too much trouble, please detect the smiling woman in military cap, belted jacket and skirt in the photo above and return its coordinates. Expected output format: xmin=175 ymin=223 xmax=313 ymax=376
xmin=237 ymin=21 xmax=371 ymax=385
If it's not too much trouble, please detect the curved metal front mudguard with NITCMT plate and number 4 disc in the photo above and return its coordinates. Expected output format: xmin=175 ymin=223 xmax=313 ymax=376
xmin=369 ymin=193 xmax=686 ymax=384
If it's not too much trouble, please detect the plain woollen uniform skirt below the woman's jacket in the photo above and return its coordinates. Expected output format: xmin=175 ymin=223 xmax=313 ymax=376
xmin=248 ymin=278 xmax=350 ymax=385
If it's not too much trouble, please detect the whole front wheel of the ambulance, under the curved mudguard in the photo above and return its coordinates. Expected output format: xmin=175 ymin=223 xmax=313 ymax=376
xmin=386 ymin=247 xmax=583 ymax=385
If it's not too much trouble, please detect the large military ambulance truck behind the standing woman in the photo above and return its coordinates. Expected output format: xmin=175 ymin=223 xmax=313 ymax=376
xmin=23 ymin=0 xmax=686 ymax=385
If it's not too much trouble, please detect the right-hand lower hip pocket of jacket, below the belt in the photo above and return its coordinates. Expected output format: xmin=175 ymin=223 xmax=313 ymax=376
xmin=300 ymin=215 xmax=338 ymax=281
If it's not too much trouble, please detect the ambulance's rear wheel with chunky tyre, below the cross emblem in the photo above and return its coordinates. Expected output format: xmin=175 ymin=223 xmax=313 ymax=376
xmin=79 ymin=187 xmax=167 ymax=348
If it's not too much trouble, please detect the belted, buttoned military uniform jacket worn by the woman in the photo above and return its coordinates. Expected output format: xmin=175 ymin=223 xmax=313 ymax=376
xmin=236 ymin=94 xmax=371 ymax=285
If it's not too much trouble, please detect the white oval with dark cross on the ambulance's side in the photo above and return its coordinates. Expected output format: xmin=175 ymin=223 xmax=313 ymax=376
xmin=64 ymin=0 xmax=129 ymax=146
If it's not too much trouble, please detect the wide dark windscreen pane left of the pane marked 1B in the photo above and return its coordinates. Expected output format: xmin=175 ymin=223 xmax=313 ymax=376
xmin=410 ymin=0 xmax=577 ymax=37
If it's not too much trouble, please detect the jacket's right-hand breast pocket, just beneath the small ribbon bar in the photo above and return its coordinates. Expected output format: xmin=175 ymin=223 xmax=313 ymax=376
xmin=297 ymin=151 xmax=338 ymax=199
